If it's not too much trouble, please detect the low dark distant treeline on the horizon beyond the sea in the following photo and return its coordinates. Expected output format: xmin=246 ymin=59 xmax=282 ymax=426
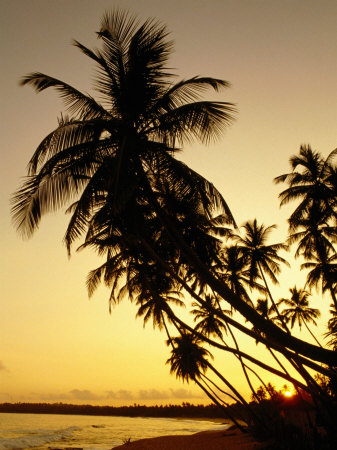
xmin=0 ymin=403 xmax=231 ymax=418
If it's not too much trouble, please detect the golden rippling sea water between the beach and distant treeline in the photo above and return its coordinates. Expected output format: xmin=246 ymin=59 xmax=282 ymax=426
xmin=0 ymin=413 xmax=229 ymax=450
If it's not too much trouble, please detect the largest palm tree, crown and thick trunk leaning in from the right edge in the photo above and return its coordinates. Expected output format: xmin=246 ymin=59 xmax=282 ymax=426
xmin=13 ymin=10 xmax=334 ymax=376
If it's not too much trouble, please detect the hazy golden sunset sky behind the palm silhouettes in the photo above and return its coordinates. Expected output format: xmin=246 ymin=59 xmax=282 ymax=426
xmin=0 ymin=0 xmax=337 ymax=405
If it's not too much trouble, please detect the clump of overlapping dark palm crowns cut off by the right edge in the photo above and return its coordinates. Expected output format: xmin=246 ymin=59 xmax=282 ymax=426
xmin=274 ymin=146 xmax=337 ymax=308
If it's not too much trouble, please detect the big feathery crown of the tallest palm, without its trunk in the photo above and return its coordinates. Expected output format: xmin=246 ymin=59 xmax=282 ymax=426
xmin=13 ymin=10 xmax=234 ymax=248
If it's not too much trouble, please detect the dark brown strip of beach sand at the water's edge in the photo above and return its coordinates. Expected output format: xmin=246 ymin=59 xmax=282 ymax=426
xmin=113 ymin=428 xmax=271 ymax=450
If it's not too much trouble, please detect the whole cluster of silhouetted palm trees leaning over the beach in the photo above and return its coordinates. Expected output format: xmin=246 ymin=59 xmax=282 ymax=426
xmin=12 ymin=10 xmax=337 ymax=440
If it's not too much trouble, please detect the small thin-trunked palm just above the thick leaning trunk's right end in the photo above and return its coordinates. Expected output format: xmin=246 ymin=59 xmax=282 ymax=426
xmin=277 ymin=286 xmax=321 ymax=345
